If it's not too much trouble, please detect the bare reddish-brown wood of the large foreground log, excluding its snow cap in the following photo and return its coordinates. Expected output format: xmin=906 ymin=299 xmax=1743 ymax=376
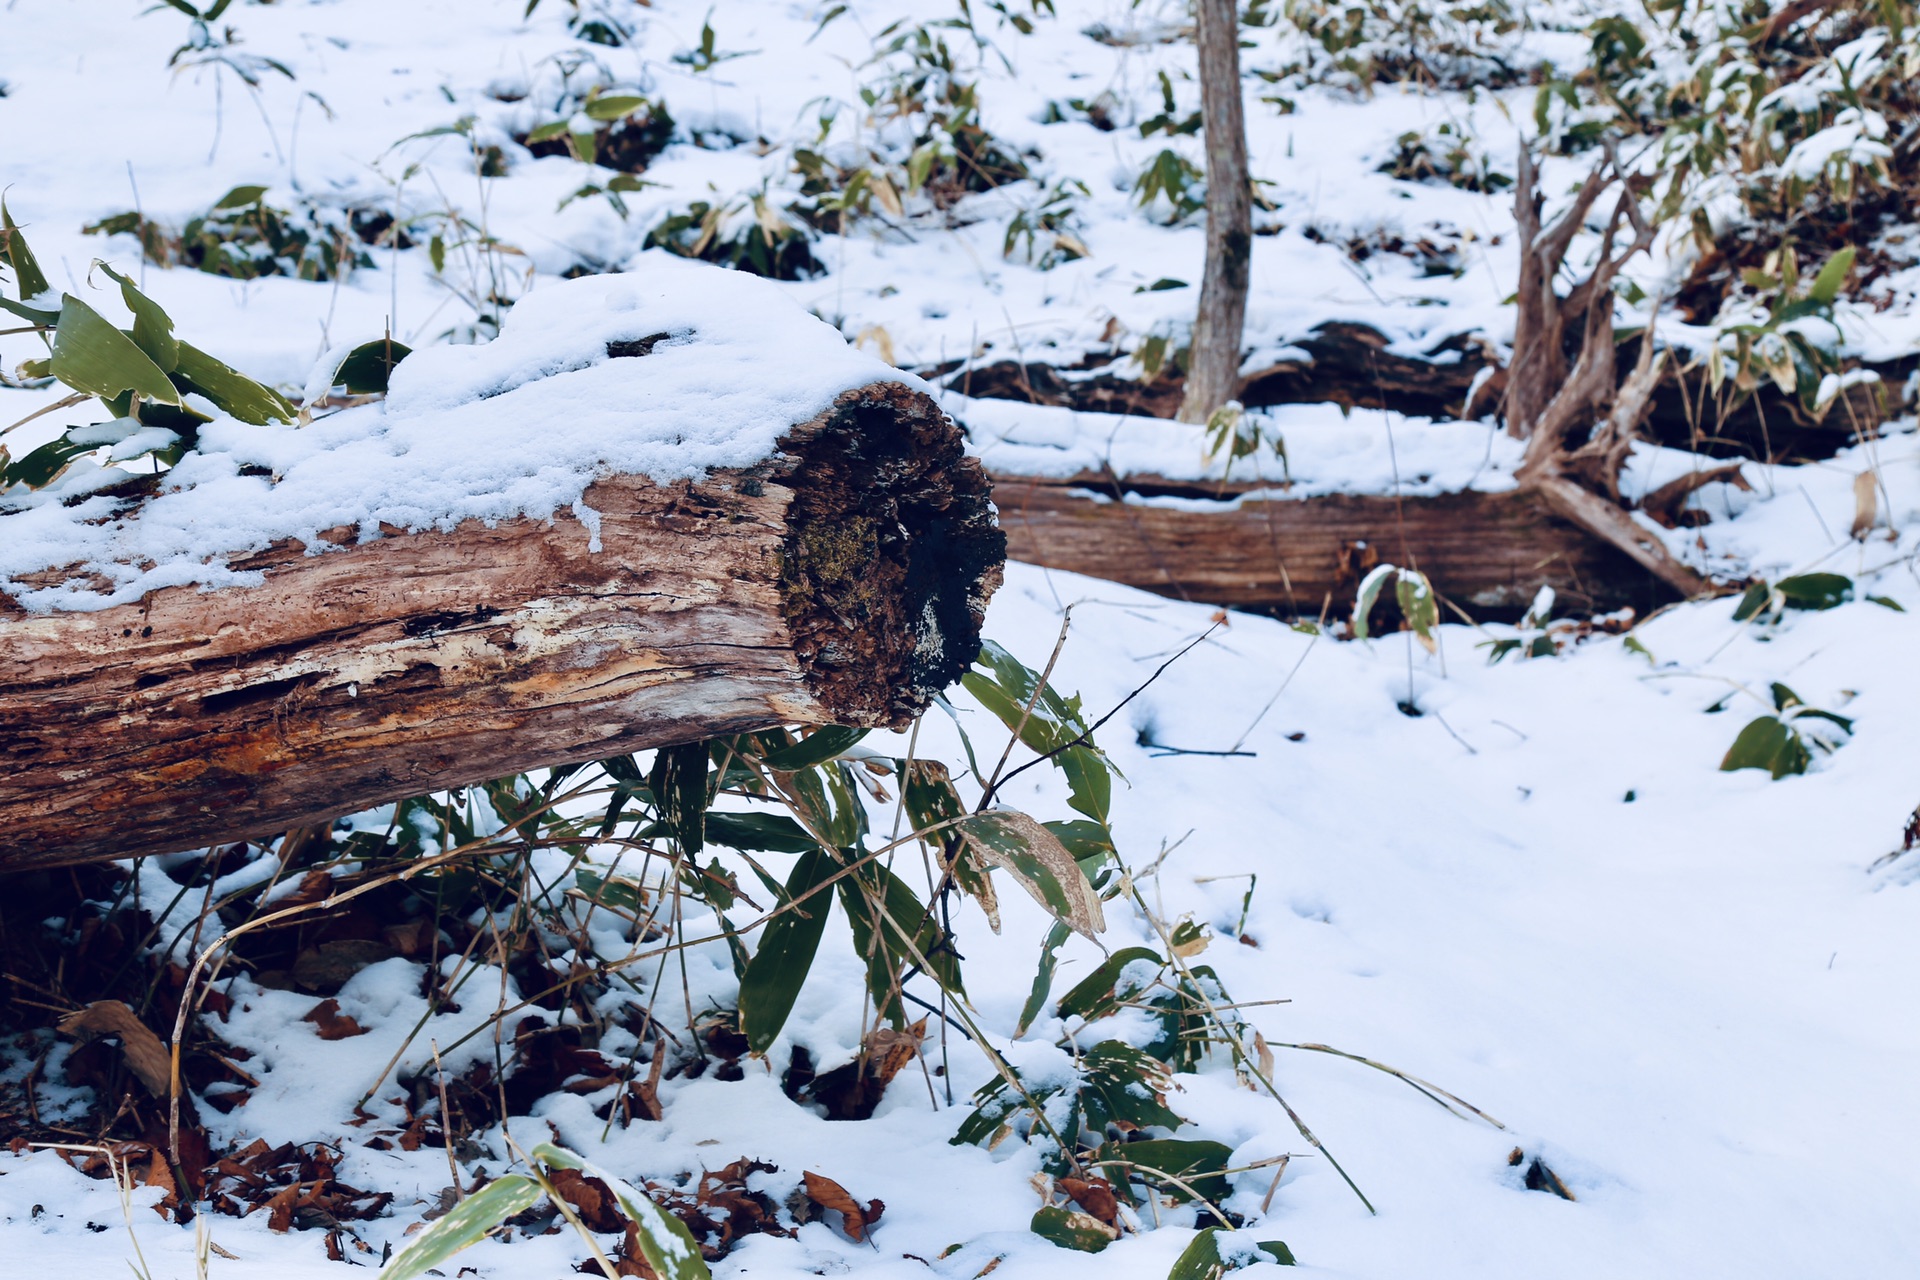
xmin=0 ymin=384 xmax=1006 ymax=869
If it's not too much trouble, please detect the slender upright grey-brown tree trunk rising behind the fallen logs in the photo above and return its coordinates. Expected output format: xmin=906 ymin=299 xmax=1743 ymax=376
xmin=1179 ymin=0 xmax=1254 ymax=422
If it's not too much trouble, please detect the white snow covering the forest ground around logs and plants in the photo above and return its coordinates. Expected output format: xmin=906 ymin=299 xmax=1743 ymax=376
xmin=0 ymin=0 xmax=1920 ymax=1280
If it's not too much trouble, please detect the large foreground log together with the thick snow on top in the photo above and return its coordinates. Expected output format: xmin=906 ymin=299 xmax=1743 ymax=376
xmin=0 ymin=263 xmax=1004 ymax=869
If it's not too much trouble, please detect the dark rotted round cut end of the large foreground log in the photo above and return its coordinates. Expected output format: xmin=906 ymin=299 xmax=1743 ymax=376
xmin=780 ymin=382 xmax=1006 ymax=727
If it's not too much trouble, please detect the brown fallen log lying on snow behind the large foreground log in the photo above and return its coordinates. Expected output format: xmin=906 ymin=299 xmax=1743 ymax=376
xmin=993 ymin=474 xmax=1672 ymax=620
